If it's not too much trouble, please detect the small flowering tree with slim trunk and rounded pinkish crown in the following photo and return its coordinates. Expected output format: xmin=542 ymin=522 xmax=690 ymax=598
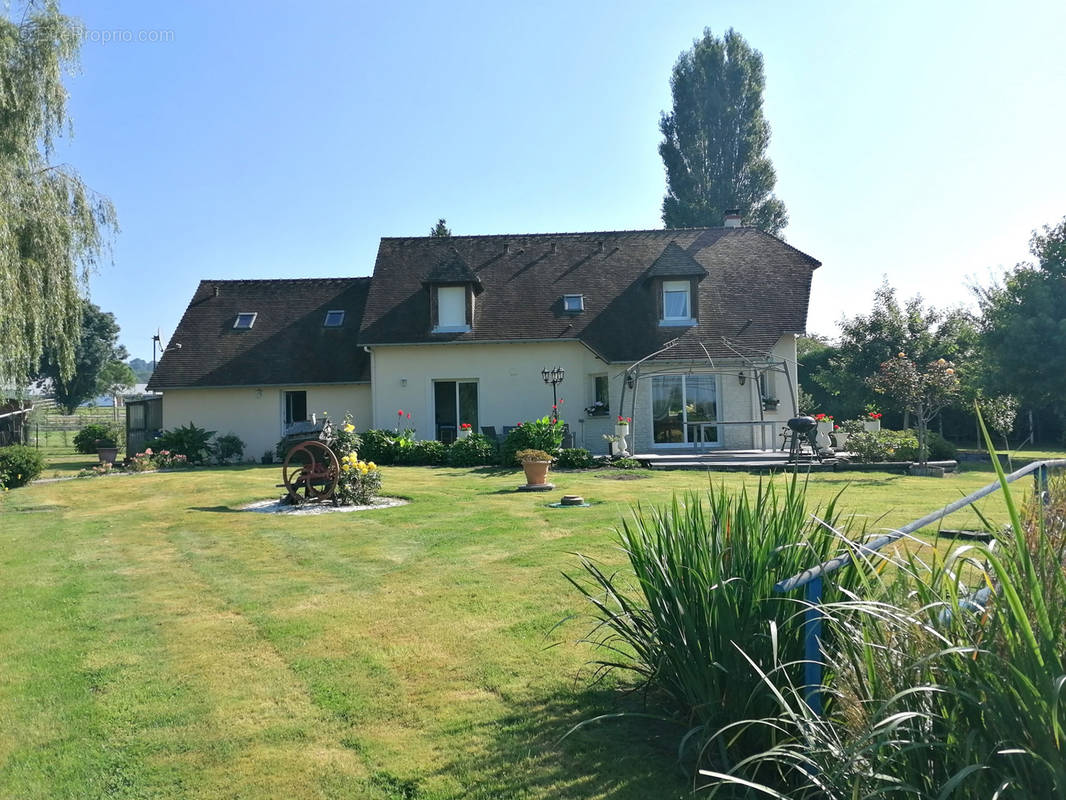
xmin=870 ymin=353 xmax=959 ymax=464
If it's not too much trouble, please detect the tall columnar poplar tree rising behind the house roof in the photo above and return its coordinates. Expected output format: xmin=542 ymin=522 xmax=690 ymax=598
xmin=659 ymin=29 xmax=788 ymax=234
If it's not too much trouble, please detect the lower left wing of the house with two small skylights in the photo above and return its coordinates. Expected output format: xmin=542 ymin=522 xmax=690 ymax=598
xmin=148 ymin=277 xmax=370 ymax=459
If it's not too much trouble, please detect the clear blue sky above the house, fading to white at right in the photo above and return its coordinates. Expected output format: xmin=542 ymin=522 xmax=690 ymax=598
xmin=51 ymin=0 xmax=1066 ymax=358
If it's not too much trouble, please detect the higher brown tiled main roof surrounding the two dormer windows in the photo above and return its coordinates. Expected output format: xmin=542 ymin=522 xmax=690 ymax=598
xmin=359 ymin=227 xmax=820 ymax=362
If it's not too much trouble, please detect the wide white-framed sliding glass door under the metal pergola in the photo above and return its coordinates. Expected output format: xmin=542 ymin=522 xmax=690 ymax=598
xmin=651 ymin=374 xmax=721 ymax=447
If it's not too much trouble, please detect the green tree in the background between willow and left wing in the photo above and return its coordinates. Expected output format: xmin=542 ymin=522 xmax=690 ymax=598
xmin=41 ymin=300 xmax=129 ymax=414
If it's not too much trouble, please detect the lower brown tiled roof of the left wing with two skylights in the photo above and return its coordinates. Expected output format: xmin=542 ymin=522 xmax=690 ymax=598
xmin=148 ymin=277 xmax=370 ymax=389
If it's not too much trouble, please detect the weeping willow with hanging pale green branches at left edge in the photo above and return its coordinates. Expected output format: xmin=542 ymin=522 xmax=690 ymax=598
xmin=0 ymin=0 xmax=114 ymax=386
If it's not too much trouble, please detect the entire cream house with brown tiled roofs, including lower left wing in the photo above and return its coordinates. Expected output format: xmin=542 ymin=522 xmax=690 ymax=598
xmin=150 ymin=224 xmax=820 ymax=454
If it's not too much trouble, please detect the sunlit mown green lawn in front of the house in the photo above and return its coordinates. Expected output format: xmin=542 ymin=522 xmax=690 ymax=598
xmin=0 ymin=466 xmax=1048 ymax=800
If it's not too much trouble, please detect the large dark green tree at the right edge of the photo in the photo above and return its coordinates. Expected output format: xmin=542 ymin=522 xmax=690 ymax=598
xmin=976 ymin=218 xmax=1066 ymax=418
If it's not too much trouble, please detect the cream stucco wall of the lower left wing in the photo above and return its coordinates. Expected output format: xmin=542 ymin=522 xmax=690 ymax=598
xmin=157 ymin=383 xmax=373 ymax=461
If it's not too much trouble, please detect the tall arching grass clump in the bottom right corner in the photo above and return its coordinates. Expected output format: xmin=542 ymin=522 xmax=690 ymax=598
xmin=702 ymin=416 xmax=1066 ymax=800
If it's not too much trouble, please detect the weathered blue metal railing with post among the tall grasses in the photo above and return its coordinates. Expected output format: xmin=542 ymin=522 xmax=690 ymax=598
xmin=774 ymin=459 xmax=1066 ymax=714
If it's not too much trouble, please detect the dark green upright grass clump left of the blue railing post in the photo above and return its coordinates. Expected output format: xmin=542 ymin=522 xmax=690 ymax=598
xmin=567 ymin=476 xmax=858 ymax=763
